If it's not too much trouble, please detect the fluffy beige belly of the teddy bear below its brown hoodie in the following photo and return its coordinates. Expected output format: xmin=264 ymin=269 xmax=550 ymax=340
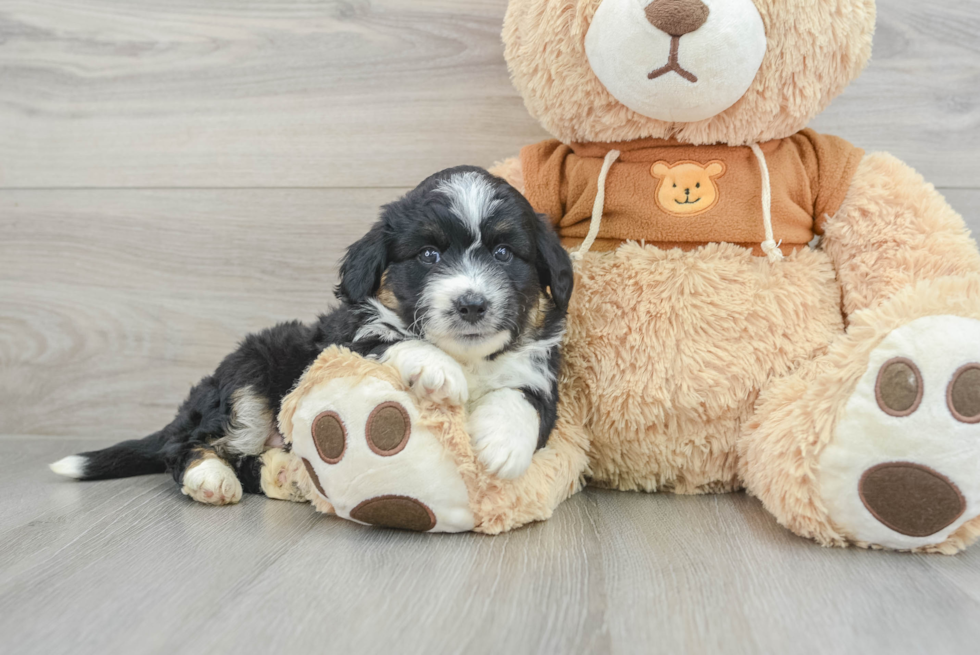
xmin=562 ymin=243 xmax=842 ymax=493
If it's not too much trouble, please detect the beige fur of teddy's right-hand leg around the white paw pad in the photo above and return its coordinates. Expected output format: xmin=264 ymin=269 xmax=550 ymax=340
xmin=738 ymin=275 xmax=980 ymax=553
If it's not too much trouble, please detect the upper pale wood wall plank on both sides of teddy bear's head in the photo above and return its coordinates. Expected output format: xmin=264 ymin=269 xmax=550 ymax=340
xmin=0 ymin=0 xmax=980 ymax=188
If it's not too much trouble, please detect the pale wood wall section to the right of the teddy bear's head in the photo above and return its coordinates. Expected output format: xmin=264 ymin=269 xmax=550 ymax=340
xmin=813 ymin=0 xmax=980 ymax=188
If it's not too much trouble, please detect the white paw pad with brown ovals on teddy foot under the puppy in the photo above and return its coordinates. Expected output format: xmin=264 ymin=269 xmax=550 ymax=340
xmin=292 ymin=378 xmax=474 ymax=532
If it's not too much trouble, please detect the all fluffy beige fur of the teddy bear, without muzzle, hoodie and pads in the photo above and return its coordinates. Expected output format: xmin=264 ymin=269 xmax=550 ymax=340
xmin=280 ymin=0 xmax=980 ymax=553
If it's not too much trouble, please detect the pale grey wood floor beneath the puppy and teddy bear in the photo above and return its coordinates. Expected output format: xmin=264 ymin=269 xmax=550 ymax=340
xmin=0 ymin=437 xmax=980 ymax=655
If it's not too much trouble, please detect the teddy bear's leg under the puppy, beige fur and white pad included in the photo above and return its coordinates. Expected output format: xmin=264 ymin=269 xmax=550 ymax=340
xmin=279 ymin=348 xmax=585 ymax=533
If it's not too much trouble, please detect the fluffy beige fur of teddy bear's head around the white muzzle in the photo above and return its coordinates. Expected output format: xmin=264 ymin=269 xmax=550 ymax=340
xmin=503 ymin=0 xmax=875 ymax=145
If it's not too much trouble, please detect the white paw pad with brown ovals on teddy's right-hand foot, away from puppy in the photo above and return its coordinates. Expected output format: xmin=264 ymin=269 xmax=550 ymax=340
xmin=819 ymin=316 xmax=980 ymax=550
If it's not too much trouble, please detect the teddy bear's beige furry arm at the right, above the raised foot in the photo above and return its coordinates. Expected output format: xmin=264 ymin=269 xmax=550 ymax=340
xmin=823 ymin=153 xmax=980 ymax=316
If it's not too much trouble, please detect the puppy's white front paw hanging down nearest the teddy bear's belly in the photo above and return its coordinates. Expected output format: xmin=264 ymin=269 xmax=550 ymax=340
xmin=467 ymin=389 xmax=540 ymax=480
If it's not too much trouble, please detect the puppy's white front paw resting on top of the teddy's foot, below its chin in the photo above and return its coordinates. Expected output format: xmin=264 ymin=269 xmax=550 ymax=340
xmin=381 ymin=341 xmax=469 ymax=405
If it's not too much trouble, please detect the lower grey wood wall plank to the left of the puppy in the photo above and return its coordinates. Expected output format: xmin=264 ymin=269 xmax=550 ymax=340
xmin=0 ymin=189 xmax=402 ymax=438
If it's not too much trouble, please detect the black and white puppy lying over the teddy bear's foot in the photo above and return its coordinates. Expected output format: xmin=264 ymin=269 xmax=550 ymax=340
xmin=52 ymin=166 xmax=572 ymax=504
